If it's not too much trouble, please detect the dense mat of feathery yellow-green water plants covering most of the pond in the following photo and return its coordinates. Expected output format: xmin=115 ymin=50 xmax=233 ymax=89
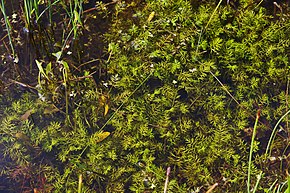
xmin=0 ymin=0 xmax=290 ymax=192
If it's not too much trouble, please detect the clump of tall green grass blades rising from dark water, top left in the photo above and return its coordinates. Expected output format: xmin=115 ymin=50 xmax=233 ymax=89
xmin=0 ymin=0 xmax=85 ymax=66
